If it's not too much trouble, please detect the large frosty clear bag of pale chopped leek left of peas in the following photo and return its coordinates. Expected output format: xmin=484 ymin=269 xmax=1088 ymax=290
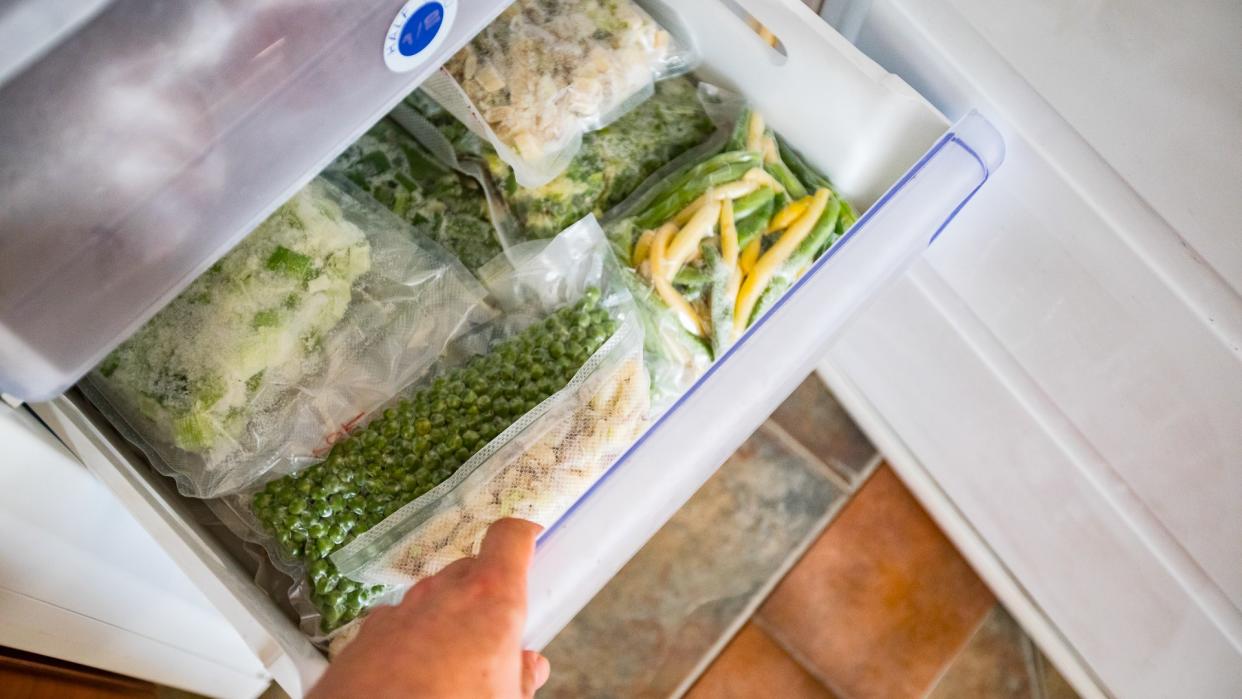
xmin=82 ymin=178 xmax=492 ymax=498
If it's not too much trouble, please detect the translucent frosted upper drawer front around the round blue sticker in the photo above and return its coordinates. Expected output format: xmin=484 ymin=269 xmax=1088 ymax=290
xmin=0 ymin=0 xmax=507 ymax=400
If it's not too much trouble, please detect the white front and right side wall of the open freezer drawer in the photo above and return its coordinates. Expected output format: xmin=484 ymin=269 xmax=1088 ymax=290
xmin=525 ymin=0 xmax=1004 ymax=647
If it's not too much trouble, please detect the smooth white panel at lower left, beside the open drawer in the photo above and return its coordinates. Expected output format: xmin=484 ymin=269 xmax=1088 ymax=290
xmin=0 ymin=404 xmax=271 ymax=697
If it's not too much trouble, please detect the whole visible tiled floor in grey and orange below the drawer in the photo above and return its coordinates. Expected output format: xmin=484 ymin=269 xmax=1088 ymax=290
xmin=540 ymin=376 xmax=1074 ymax=699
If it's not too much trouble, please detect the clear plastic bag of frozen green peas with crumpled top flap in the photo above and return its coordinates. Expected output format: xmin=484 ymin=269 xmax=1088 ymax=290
xmin=217 ymin=219 xmax=646 ymax=641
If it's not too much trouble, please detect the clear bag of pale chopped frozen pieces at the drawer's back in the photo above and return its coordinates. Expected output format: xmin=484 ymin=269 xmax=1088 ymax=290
xmin=424 ymin=0 xmax=693 ymax=187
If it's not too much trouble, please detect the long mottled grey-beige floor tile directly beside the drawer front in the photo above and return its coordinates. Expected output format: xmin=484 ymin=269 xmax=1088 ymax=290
xmin=539 ymin=427 xmax=845 ymax=699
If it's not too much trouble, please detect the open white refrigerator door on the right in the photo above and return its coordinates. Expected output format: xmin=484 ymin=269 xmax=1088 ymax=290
xmin=822 ymin=0 xmax=1242 ymax=697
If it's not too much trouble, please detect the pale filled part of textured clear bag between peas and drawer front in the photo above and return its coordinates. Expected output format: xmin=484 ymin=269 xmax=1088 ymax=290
xmin=334 ymin=319 xmax=650 ymax=587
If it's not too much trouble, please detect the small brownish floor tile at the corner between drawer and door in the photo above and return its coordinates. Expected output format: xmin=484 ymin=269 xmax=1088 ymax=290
xmin=771 ymin=374 xmax=876 ymax=483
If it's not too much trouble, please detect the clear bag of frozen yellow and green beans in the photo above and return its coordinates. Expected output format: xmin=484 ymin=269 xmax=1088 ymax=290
xmin=605 ymin=84 xmax=856 ymax=406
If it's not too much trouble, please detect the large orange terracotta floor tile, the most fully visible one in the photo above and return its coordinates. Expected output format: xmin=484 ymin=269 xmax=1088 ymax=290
xmin=759 ymin=466 xmax=995 ymax=699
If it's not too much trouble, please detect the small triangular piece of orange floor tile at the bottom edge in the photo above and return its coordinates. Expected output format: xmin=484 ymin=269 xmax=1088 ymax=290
xmin=686 ymin=623 xmax=832 ymax=699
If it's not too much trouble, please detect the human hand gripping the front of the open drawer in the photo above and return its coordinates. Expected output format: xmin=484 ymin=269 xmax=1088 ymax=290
xmin=309 ymin=519 xmax=550 ymax=699
